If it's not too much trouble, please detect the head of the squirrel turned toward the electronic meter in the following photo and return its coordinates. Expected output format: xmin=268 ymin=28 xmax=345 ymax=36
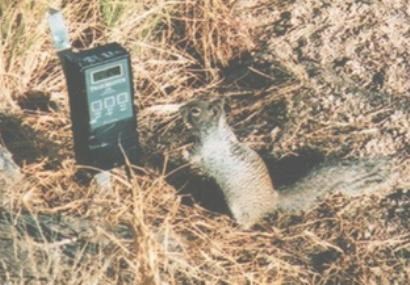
xmin=179 ymin=97 xmax=225 ymax=133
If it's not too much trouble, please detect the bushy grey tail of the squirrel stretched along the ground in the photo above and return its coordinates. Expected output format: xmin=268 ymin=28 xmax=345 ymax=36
xmin=277 ymin=159 xmax=395 ymax=210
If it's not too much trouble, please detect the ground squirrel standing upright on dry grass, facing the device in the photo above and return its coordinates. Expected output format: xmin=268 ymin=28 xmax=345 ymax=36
xmin=179 ymin=98 xmax=398 ymax=228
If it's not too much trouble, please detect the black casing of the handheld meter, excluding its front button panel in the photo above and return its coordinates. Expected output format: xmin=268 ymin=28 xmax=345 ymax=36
xmin=59 ymin=43 xmax=139 ymax=170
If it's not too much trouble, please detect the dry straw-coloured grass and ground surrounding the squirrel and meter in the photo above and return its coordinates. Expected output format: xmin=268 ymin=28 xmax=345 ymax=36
xmin=0 ymin=0 xmax=410 ymax=285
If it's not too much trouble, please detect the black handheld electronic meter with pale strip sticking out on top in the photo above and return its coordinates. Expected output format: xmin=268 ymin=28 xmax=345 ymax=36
xmin=49 ymin=11 xmax=138 ymax=169
